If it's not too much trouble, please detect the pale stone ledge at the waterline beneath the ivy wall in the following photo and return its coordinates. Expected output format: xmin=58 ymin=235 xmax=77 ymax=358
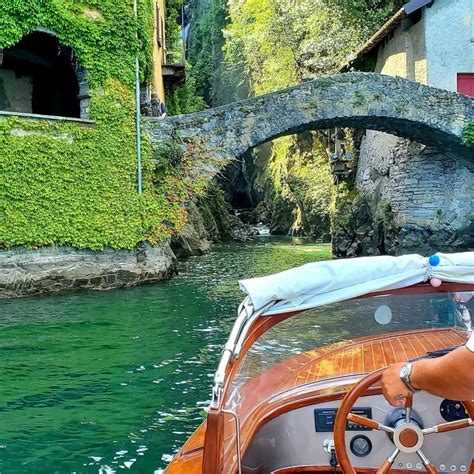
xmin=0 ymin=244 xmax=176 ymax=298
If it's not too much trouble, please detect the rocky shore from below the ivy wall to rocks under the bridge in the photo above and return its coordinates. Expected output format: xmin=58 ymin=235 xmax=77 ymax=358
xmin=0 ymin=194 xmax=257 ymax=299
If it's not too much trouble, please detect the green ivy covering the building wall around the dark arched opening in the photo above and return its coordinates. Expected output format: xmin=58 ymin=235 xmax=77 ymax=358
xmin=0 ymin=0 xmax=198 ymax=249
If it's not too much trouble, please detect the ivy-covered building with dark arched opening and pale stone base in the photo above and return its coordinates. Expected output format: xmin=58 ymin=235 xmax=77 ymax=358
xmin=0 ymin=0 xmax=189 ymax=298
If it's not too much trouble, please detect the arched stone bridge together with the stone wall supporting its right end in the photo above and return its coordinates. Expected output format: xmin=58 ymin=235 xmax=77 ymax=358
xmin=148 ymin=73 xmax=474 ymax=256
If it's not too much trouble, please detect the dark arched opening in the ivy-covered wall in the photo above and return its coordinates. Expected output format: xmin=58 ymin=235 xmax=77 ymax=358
xmin=0 ymin=31 xmax=81 ymax=117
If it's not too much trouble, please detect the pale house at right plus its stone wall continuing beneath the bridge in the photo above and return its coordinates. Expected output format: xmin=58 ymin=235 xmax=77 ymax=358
xmin=345 ymin=0 xmax=474 ymax=253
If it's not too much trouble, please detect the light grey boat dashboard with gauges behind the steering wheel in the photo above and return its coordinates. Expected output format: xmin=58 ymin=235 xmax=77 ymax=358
xmin=243 ymin=392 xmax=474 ymax=474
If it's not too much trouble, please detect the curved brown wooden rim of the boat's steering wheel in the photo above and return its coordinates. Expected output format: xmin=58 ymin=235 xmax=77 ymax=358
xmin=334 ymin=368 xmax=474 ymax=474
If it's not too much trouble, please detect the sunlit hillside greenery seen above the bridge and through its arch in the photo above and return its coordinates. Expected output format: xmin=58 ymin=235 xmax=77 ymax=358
xmin=181 ymin=0 xmax=404 ymax=239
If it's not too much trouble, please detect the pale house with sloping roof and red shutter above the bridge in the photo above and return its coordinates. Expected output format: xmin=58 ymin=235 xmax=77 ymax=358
xmin=352 ymin=0 xmax=474 ymax=97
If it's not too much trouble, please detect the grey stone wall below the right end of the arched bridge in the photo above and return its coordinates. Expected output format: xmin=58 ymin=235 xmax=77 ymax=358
xmin=356 ymin=131 xmax=474 ymax=253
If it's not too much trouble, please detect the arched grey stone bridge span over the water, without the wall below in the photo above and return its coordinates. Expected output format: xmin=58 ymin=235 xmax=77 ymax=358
xmin=148 ymin=73 xmax=474 ymax=159
